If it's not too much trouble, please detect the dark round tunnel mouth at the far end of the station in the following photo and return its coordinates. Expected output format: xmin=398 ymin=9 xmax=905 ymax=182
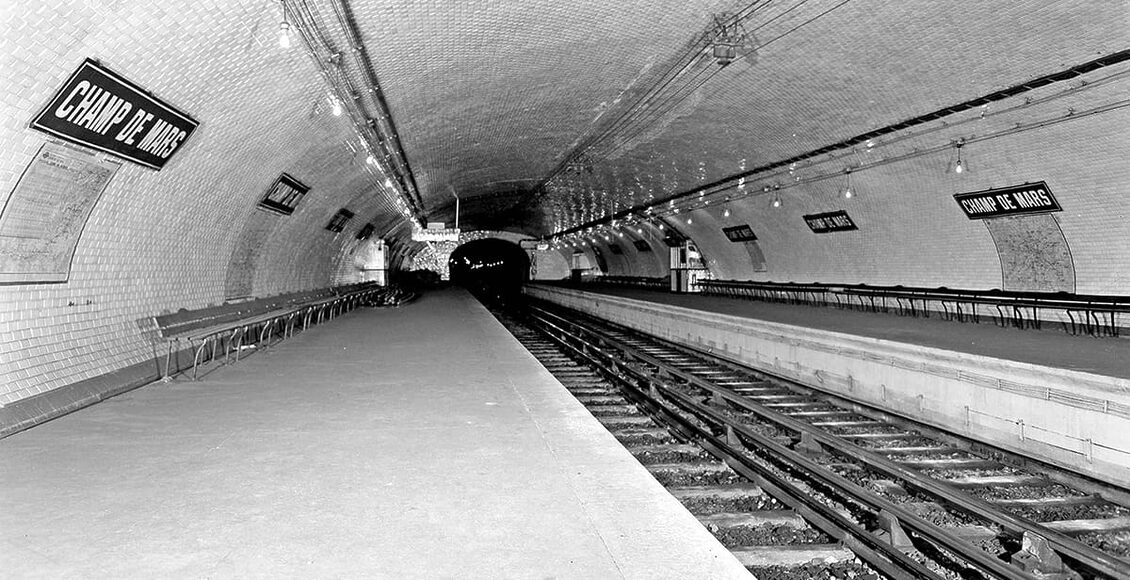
xmin=447 ymin=237 xmax=530 ymax=301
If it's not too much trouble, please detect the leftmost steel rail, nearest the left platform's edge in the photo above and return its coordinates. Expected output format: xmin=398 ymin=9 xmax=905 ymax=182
xmin=528 ymin=309 xmax=944 ymax=580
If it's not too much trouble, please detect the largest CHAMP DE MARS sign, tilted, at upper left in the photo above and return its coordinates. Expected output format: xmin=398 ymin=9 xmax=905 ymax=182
xmin=32 ymin=59 xmax=200 ymax=170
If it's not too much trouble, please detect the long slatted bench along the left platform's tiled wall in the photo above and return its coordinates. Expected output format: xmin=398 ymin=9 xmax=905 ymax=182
xmin=153 ymin=283 xmax=382 ymax=380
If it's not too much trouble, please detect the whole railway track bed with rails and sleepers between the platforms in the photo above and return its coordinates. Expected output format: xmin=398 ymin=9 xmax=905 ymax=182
xmin=492 ymin=298 xmax=1130 ymax=579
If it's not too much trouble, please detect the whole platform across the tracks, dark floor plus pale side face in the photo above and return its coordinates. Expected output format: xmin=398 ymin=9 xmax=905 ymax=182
xmin=525 ymin=284 xmax=1130 ymax=486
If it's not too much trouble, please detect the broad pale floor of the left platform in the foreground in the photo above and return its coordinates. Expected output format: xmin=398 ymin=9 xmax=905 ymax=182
xmin=0 ymin=289 xmax=748 ymax=579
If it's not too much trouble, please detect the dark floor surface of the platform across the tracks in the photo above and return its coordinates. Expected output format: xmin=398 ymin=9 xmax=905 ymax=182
xmin=565 ymin=285 xmax=1130 ymax=379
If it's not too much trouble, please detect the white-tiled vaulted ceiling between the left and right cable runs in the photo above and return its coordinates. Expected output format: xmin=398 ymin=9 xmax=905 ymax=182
xmin=325 ymin=0 xmax=1125 ymax=234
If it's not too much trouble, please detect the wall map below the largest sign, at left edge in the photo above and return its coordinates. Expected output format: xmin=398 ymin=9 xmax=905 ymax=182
xmin=0 ymin=142 xmax=122 ymax=284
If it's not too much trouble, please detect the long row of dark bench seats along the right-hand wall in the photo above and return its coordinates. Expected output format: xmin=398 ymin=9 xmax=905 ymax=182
xmin=698 ymin=280 xmax=1130 ymax=337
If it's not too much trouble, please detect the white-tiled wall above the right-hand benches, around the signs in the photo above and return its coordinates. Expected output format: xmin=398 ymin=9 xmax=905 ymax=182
xmin=610 ymin=112 xmax=1130 ymax=294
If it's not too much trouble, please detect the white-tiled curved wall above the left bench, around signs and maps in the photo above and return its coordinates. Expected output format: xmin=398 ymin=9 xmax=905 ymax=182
xmin=0 ymin=0 xmax=404 ymax=405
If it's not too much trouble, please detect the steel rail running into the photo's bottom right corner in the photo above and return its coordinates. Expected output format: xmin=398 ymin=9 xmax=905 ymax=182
xmin=531 ymin=306 xmax=1130 ymax=580
